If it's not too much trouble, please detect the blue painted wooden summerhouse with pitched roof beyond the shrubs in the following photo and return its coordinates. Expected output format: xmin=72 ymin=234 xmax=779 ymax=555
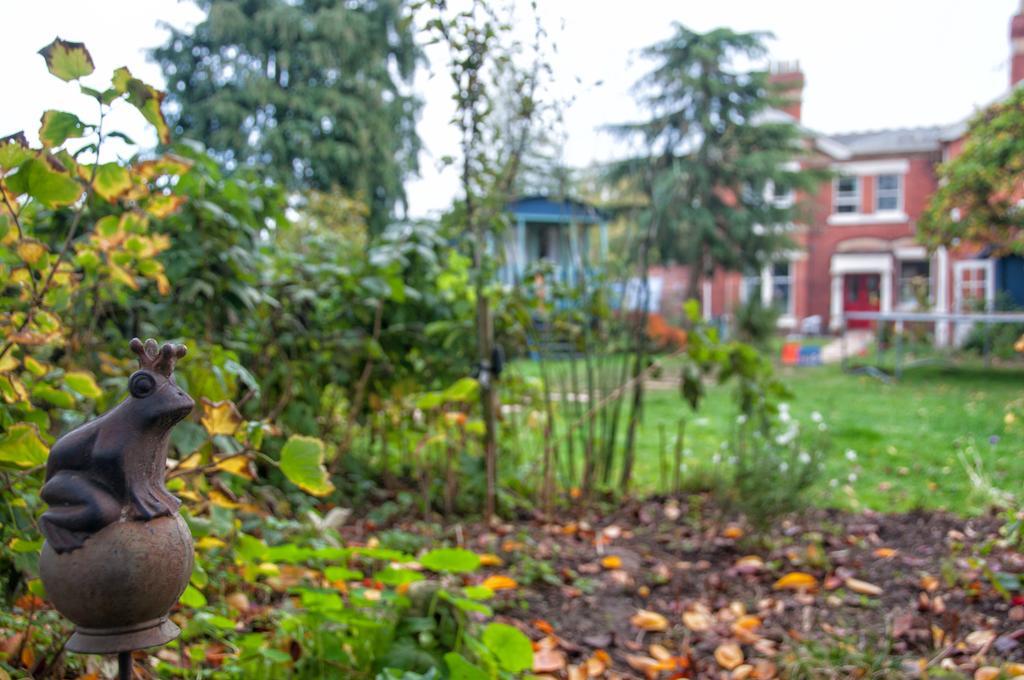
xmin=500 ymin=196 xmax=608 ymax=285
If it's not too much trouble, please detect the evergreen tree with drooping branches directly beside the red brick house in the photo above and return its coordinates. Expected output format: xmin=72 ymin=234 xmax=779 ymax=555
xmin=609 ymin=24 xmax=818 ymax=297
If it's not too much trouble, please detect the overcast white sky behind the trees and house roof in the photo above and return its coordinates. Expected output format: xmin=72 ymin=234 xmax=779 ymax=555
xmin=0 ymin=0 xmax=1020 ymax=215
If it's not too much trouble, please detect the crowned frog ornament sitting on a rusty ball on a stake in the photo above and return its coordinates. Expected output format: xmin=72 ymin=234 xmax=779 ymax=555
xmin=39 ymin=338 xmax=195 ymax=677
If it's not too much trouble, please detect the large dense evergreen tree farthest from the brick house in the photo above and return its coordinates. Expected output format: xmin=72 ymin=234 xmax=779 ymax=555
xmin=153 ymin=0 xmax=420 ymax=229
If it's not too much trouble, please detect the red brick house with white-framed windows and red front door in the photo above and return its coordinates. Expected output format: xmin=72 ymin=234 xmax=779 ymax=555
xmin=650 ymin=5 xmax=1024 ymax=344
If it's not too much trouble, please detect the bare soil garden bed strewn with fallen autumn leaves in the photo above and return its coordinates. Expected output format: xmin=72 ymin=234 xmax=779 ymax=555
xmin=350 ymin=497 xmax=1024 ymax=678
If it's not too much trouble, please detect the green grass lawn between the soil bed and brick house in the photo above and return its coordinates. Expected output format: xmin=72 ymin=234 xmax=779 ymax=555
xmin=505 ymin=362 xmax=1024 ymax=513
